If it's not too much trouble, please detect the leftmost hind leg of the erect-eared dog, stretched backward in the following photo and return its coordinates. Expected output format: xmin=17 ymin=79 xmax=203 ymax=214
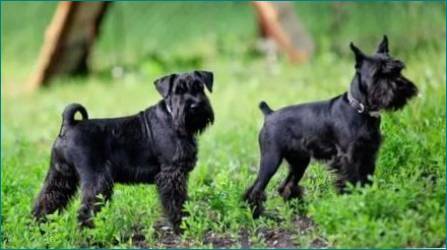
xmin=244 ymin=148 xmax=282 ymax=218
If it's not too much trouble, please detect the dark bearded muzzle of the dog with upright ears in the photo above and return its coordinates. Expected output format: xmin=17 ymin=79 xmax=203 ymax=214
xmin=368 ymin=75 xmax=418 ymax=111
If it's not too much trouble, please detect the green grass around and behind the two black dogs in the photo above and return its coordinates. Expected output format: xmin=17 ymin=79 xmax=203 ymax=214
xmin=1 ymin=3 xmax=446 ymax=248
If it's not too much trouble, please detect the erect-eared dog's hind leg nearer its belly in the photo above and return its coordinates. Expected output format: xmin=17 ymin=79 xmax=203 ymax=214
xmin=278 ymin=155 xmax=310 ymax=200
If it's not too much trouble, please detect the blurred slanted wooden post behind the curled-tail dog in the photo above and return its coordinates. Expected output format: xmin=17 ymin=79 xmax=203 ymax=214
xmin=29 ymin=2 xmax=108 ymax=89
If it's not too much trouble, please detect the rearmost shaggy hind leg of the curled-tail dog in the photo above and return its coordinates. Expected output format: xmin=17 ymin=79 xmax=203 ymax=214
xmin=32 ymin=157 xmax=78 ymax=220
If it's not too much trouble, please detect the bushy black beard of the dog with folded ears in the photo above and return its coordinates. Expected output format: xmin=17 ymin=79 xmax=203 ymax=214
xmin=173 ymin=102 xmax=214 ymax=135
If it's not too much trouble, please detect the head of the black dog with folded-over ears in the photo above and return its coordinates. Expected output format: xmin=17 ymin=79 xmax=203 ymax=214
xmin=154 ymin=71 xmax=214 ymax=135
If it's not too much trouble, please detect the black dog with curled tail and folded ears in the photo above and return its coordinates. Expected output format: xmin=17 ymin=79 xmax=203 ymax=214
xmin=33 ymin=71 xmax=214 ymax=231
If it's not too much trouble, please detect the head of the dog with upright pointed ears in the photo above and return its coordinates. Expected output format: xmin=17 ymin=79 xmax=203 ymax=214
xmin=350 ymin=36 xmax=417 ymax=111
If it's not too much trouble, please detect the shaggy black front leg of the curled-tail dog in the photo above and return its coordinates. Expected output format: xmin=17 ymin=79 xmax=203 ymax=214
xmin=155 ymin=166 xmax=188 ymax=233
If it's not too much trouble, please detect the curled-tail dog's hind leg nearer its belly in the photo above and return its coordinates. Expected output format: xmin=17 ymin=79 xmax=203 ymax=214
xmin=78 ymin=172 xmax=113 ymax=228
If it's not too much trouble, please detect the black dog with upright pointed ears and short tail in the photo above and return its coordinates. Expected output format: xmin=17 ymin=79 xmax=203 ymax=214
xmin=244 ymin=36 xmax=417 ymax=217
